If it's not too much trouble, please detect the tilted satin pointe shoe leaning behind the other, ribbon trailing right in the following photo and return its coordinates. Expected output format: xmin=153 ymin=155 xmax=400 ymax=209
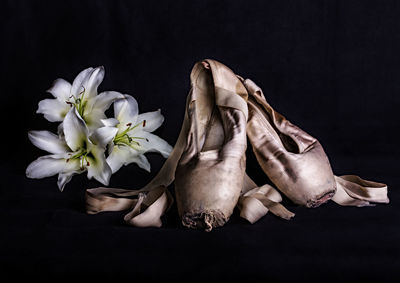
xmin=243 ymin=79 xmax=389 ymax=207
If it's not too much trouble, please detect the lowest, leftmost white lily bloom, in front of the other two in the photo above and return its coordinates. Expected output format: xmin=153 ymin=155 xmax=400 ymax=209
xmin=26 ymin=107 xmax=111 ymax=191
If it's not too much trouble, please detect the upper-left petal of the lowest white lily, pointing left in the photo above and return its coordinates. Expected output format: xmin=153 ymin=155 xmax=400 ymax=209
xmin=28 ymin=131 xmax=69 ymax=153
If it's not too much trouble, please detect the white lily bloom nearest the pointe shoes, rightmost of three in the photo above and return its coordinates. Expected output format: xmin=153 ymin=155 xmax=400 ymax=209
xmin=94 ymin=95 xmax=172 ymax=173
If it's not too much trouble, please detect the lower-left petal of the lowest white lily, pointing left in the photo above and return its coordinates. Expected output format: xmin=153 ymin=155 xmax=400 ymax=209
xmin=26 ymin=155 xmax=79 ymax=179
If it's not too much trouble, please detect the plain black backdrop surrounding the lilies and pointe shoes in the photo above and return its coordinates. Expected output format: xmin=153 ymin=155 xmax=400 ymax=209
xmin=0 ymin=0 xmax=400 ymax=281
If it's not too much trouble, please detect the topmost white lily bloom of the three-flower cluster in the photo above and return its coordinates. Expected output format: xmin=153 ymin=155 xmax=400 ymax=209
xmin=36 ymin=67 xmax=121 ymax=131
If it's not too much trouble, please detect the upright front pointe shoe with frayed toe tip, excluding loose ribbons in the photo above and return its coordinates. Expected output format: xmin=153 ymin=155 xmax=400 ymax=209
xmin=175 ymin=60 xmax=247 ymax=231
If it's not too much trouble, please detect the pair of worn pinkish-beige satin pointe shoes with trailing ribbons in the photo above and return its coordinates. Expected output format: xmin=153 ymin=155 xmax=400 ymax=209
xmin=86 ymin=60 xmax=389 ymax=231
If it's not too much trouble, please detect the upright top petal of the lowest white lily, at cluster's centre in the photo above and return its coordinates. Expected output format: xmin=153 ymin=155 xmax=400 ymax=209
xmin=63 ymin=107 xmax=88 ymax=151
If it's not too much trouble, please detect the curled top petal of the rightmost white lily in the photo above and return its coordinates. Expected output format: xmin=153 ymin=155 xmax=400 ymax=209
xmin=114 ymin=95 xmax=139 ymax=124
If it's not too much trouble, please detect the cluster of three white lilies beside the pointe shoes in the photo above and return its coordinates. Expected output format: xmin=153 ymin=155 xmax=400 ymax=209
xmin=26 ymin=67 xmax=172 ymax=191
